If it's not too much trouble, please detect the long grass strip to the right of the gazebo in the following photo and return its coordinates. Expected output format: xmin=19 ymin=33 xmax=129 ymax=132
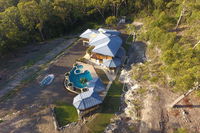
xmin=87 ymin=81 xmax=123 ymax=133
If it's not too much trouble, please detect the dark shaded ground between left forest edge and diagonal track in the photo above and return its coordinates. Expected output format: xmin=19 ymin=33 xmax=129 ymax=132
xmin=0 ymin=38 xmax=66 ymax=86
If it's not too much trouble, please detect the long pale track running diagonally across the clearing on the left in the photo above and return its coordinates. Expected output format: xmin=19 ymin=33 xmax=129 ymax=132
xmin=0 ymin=39 xmax=75 ymax=98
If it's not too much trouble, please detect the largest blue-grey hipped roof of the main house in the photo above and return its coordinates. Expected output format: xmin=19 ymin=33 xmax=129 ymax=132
xmin=92 ymin=36 xmax=122 ymax=57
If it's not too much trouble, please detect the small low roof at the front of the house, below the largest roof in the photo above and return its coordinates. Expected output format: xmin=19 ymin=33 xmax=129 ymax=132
xmin=103 ymin=58 xmax=122 ymax=67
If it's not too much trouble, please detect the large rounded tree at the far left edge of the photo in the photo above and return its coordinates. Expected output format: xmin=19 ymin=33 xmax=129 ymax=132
xmin=0 ymin=6 xmax=27 ymax=51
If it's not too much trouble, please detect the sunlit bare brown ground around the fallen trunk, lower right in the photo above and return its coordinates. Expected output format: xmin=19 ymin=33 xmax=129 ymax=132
xmin=140 ymin=82 xmax=200 ymax=133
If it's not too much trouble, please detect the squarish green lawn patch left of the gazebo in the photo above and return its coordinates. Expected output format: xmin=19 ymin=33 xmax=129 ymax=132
xmin=54 ymin=103 xmax=78 ymax=127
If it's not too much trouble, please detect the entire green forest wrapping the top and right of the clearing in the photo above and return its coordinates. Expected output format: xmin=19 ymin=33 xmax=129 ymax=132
xmin=0 ymin=0 xmax=200 ymax=90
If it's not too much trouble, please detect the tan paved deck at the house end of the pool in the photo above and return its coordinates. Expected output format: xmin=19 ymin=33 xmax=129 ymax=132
xmin=76 ymin=62 xmax=99 ymax=79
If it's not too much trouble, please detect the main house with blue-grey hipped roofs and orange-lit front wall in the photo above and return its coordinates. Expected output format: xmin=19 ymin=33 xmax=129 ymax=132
xmin=79 ymin=28 xmax=125 ymax=70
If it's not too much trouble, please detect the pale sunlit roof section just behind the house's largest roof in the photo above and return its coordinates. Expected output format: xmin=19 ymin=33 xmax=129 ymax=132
xmin=89 ymin=33 xmax=111 ymax=46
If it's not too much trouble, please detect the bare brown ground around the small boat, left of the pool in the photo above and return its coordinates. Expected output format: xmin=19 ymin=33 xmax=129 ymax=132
xmin=0 ymin=39 xmax=86 ymax=133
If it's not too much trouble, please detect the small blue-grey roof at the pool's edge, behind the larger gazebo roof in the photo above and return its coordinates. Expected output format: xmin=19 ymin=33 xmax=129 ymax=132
xmin=87 ymin=78 xmax=106 ymax=92
